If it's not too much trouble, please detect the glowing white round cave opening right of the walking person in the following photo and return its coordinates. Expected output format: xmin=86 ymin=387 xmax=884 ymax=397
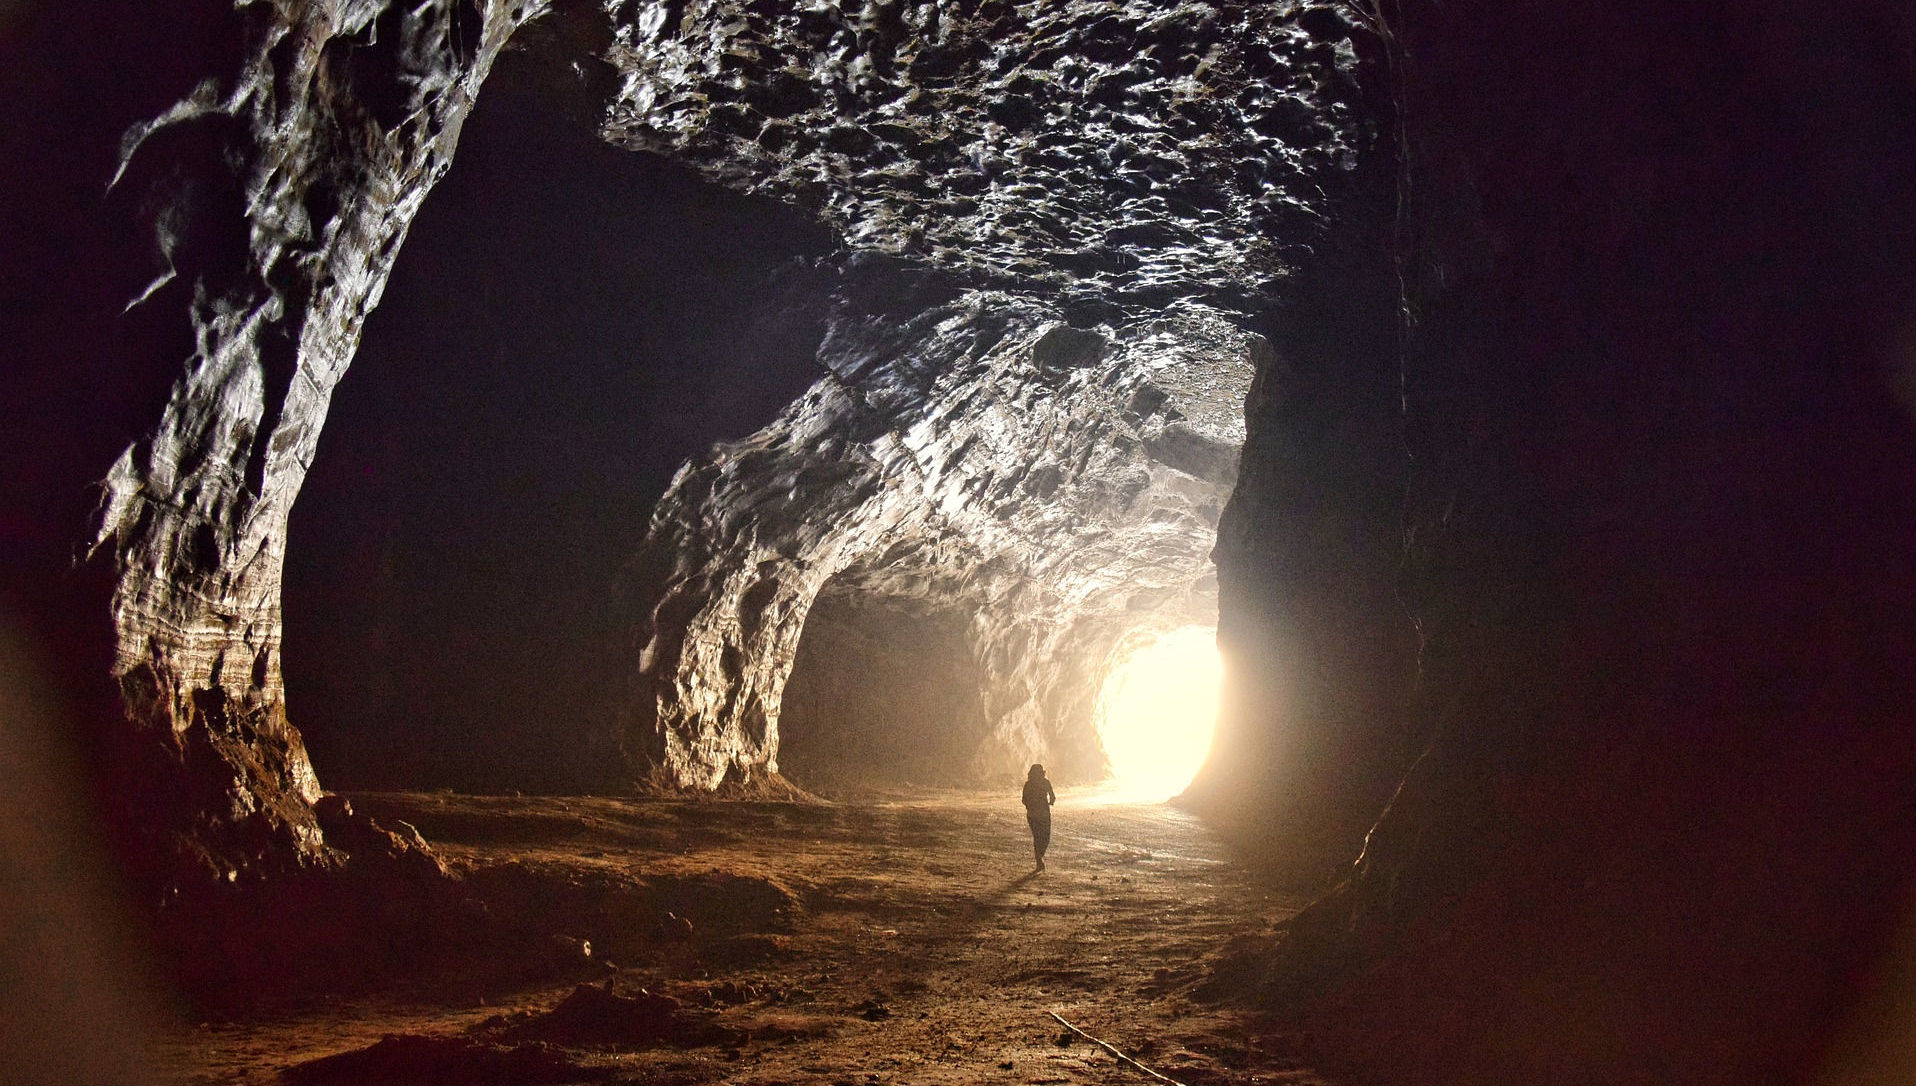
xmin=1098 ymin=626 xmax=1224 ymax=803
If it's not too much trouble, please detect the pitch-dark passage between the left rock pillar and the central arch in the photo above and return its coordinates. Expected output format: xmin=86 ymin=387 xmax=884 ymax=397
xmin=285 ymin=27 xmax=835 ymax=791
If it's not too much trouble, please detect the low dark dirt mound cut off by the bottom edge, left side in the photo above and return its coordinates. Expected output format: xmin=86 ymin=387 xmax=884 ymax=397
xmin=285 ymin=1034 xmax=611 ymax=1086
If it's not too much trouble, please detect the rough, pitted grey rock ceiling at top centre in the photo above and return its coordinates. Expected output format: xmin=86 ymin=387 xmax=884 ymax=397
xmin=607 ymin=0 xmax=1374 ymax=312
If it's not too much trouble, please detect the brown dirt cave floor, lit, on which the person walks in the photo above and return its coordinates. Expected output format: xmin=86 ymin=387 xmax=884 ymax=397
xmin=169 ymin=789 xmax=1332 ymax=1086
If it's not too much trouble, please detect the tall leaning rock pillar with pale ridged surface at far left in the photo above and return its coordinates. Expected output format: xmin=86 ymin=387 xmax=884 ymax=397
xmin=96 ymin=0 xmax=544 ymax=877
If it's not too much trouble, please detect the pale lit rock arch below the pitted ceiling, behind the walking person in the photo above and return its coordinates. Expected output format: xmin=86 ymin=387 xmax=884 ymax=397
xmin=627 ymin=293 xmax=1263 ymax=789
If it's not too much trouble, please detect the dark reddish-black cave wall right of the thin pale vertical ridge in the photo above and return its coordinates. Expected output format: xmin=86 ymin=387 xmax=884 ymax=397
xmin=1245 ymin=4 xmax=1916 ymax=1084
